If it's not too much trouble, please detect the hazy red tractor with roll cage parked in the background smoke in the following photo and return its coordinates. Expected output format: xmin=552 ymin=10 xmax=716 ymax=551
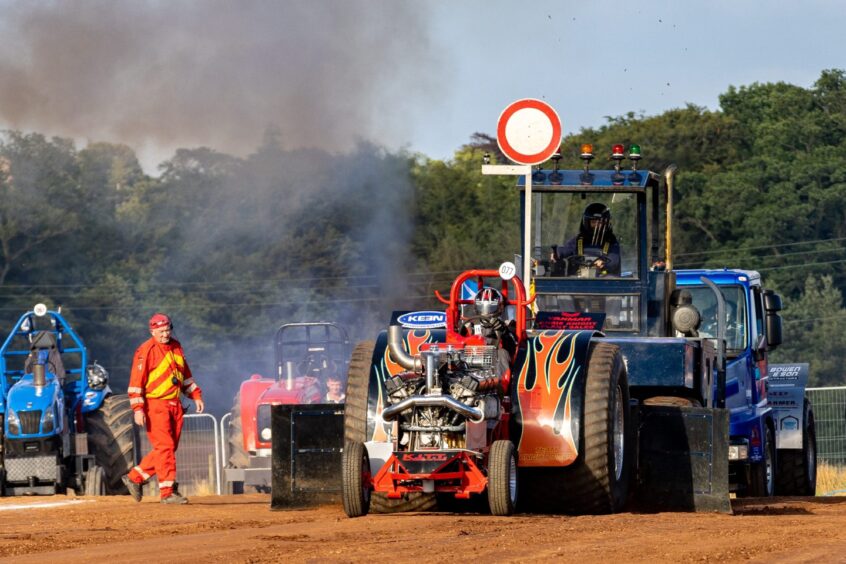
xmin=224 ymin=322 xmax=350 ymax=493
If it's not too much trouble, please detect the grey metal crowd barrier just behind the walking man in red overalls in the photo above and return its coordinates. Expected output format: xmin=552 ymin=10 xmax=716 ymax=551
xmin=140 ymin=413 xmax=223 ymax=496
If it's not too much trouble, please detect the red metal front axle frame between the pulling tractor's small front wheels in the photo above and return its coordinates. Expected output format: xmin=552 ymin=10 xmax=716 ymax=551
xmin=372 ymin=451 xmax=488 ymax=499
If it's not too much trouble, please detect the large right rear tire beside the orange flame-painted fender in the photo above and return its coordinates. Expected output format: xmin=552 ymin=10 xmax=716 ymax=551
xmin=520 ymin=342 xmax=632 ymax=515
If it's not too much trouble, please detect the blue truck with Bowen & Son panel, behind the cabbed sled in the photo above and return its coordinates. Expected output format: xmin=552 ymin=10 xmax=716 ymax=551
xmin=676 ymin=269 xmax=816 ymax=497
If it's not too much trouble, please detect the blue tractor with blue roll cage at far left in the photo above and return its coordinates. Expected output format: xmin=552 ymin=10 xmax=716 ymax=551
xmin=0 ymin=304 xmax=137 ymax=496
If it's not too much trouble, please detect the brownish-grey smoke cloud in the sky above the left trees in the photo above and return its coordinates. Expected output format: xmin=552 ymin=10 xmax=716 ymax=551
xmin=0 ymin=0 xmax=439 ymax=159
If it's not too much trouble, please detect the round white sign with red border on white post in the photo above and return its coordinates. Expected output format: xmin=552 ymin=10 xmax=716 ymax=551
xmin=496 ymin=98 xmax=561 ymax=165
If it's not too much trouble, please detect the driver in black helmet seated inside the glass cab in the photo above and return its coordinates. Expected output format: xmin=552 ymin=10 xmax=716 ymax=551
xmin=550 ymin=202 xmax=620 ymax=276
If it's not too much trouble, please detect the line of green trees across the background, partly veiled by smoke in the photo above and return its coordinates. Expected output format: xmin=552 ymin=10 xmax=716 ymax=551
xmin=0 ymin=70 xmax=846 ymax=410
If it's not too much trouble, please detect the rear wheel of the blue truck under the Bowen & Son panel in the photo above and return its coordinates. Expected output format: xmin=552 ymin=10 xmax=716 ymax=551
xmin=776 ymin=399 xmax=817 ymax=496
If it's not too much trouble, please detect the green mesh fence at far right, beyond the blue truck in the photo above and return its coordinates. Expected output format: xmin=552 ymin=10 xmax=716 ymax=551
xmin=805 ymin=386 xmax=846 ymax=466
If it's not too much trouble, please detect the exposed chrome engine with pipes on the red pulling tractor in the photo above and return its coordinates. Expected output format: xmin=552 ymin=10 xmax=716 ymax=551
xmin=382 ymin=327 xmax=502 ymax=450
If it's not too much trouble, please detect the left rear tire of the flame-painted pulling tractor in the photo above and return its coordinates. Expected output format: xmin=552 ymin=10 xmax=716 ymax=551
xmin=344 ymin=341 xmax=437 ymax=513
